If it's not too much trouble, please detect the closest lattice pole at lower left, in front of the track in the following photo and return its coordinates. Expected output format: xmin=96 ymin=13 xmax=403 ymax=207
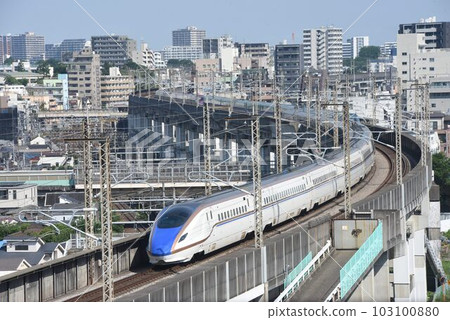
xmin=99 ymin=139 xmax=114 ymax=302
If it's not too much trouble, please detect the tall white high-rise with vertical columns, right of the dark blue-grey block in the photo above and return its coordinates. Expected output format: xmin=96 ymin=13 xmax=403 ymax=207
xmin=303 ymin=27 xmax=343 ymax=75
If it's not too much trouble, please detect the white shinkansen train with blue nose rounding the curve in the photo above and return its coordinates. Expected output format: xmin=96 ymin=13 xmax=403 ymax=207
xmin=147 ymin=124 xmax=374 ymax=264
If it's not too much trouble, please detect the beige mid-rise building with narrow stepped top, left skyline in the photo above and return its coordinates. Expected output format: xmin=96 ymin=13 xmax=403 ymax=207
xmin=67 ymin=47 xmax=101 ymax=109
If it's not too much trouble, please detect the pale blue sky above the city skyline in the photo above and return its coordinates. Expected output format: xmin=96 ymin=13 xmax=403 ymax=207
xmin=0 ymin=0 xmax=450 ymax=50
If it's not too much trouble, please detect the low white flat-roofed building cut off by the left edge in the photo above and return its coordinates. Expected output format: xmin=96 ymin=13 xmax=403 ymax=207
xmin=0 ymin=182 xmax=37 ymax=209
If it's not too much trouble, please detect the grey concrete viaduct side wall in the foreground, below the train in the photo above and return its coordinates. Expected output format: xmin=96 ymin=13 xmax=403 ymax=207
xmin=128 ymin=218 xmax=330 ymax=302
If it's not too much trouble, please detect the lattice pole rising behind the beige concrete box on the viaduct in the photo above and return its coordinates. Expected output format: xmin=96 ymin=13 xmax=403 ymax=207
xmin=342 ymin=100 xmax=352 ymax=219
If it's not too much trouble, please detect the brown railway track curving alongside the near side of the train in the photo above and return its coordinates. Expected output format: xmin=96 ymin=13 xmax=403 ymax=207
xmin=66 ymin=144 xmax=400 ymax=302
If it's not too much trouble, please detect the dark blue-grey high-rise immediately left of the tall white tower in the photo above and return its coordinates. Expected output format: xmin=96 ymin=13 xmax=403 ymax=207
xmin=275 ymin=44 xmax=303 ymax=98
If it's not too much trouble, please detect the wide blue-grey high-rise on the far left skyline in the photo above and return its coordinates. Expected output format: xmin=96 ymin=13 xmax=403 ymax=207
xmin=11 ymin=32 xmax=45 ymax=61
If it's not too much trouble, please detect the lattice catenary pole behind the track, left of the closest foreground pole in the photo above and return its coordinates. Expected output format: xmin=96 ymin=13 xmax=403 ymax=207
xmin=83 ymin=117 xmax=95 ymax=284
